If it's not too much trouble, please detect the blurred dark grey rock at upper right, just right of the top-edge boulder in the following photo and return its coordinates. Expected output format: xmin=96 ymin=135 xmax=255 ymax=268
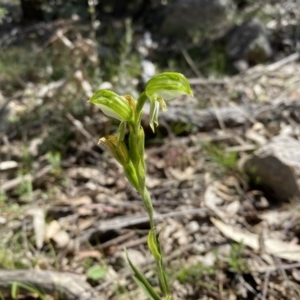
xmin=227 ymin=19 xmax=272 ymax=63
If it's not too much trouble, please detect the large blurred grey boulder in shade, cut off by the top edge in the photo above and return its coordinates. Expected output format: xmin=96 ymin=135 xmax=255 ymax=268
xmin=160 ymin=0 xmax=235 ymax=36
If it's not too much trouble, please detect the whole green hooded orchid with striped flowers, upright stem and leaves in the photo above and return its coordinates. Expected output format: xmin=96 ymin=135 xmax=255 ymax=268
xmin=89 ymin=72 xmax=192 ymax=300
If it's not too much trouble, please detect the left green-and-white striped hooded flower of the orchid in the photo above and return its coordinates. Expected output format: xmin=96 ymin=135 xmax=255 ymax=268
xmin=88 ymin=90 xmax=133 ymax=122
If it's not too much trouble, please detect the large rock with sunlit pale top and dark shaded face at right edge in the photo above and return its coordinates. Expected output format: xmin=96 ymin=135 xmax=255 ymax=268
xmin=243 ymin=135 xmax=300 ymax=200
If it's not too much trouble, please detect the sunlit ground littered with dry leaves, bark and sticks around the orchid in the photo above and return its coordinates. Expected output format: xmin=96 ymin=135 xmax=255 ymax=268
xmin=0 ymin=1 xmax=300 ymax=300
